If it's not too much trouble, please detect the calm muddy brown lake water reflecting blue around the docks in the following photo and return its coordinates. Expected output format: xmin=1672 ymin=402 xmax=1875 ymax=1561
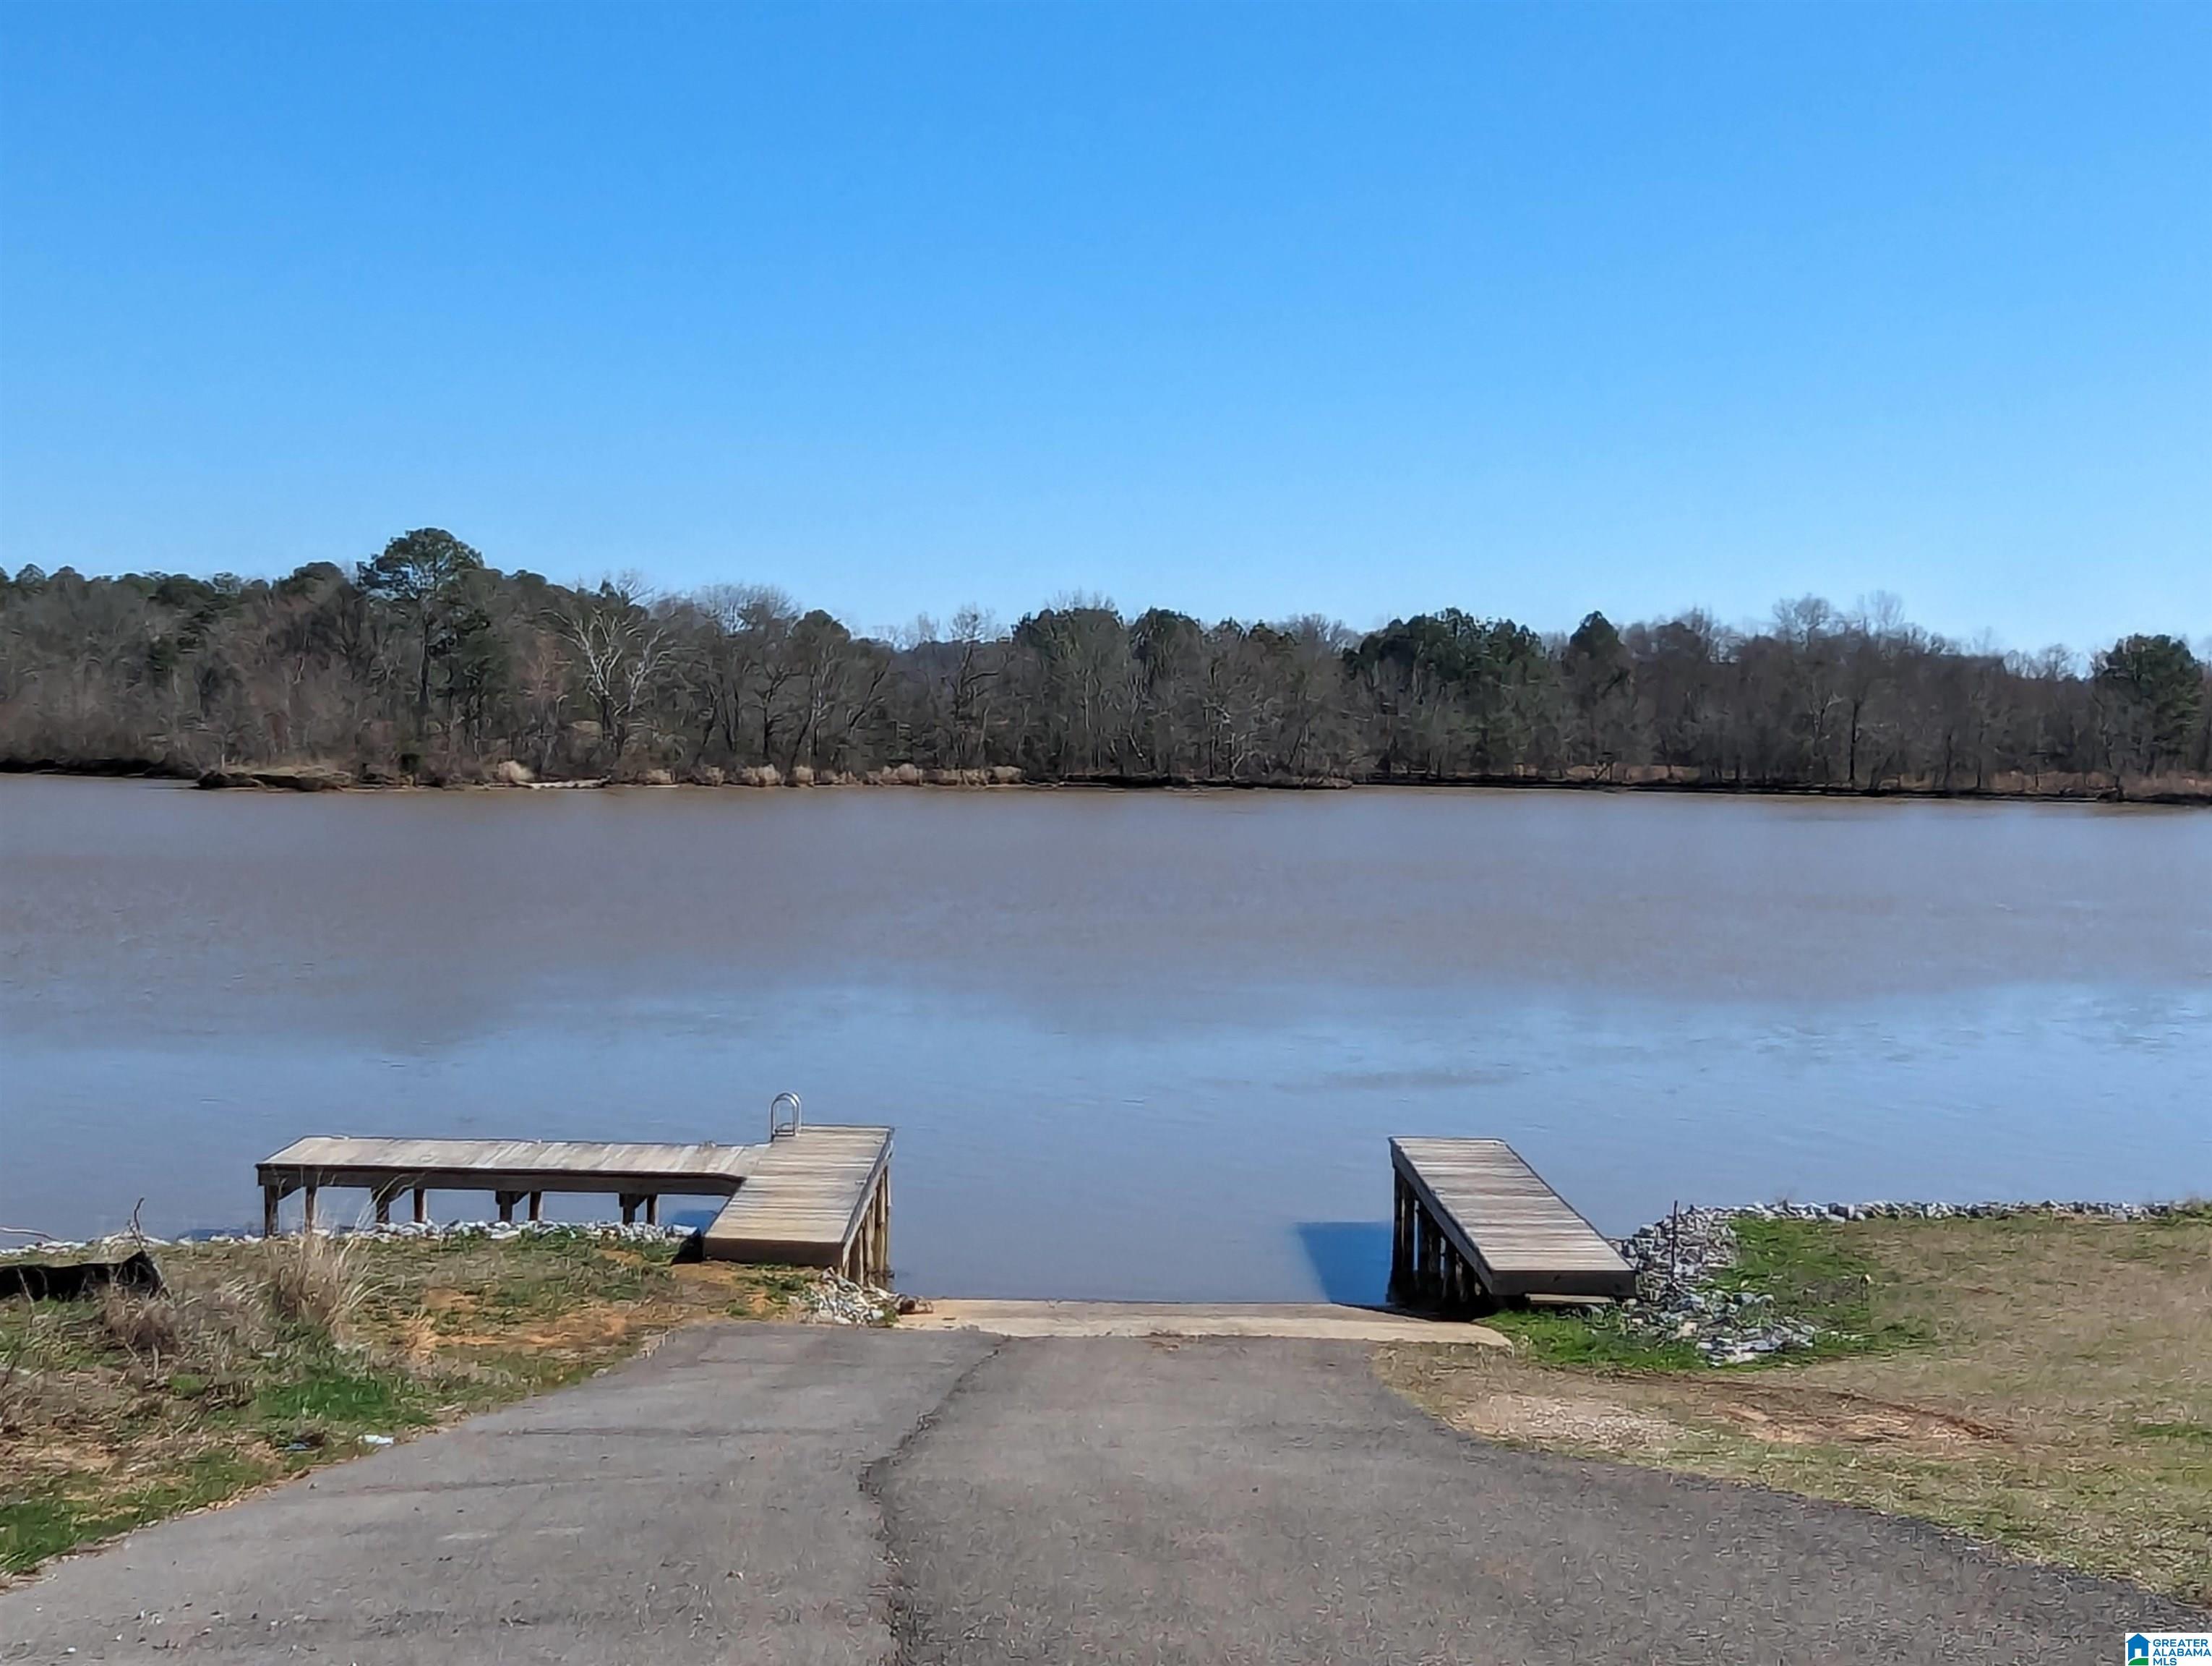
xmin=0 ymin=779 xmax=2212 ymax=1299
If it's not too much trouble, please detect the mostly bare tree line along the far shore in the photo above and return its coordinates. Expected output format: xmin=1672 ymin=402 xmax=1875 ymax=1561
xmin=0 ymin=529 xmax=2212 ymax=797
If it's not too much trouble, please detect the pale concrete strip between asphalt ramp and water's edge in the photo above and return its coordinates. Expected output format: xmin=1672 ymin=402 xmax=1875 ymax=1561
xmin=898 ymin=1301 xmax=1513 ymax=1347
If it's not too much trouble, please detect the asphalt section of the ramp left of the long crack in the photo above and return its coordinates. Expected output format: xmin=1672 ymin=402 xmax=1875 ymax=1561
xmin=0 ymin=1325 xmax=991 ymax=1666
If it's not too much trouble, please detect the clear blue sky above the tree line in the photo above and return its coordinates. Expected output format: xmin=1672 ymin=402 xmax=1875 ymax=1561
xmin=0 ymin=0 xmax=2212 ymax=649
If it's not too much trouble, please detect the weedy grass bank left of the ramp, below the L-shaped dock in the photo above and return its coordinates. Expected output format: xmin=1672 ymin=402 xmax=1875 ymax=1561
xmin=0 ymin=1230 xmax=810 ymax=1578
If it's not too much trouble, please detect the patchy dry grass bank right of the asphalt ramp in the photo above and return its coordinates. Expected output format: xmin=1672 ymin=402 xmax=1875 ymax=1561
xmin=1378 ymin=1208 xmax=2212 ymax=1604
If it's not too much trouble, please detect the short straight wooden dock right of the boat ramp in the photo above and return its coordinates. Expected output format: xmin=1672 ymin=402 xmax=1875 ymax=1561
xmin=1389 ymin=1140 xmax=1637 ymax=1310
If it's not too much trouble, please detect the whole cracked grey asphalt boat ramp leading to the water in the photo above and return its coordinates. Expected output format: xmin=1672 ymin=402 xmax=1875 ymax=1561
xmin=0 ymin=1325 xmax=2212 ymax=1666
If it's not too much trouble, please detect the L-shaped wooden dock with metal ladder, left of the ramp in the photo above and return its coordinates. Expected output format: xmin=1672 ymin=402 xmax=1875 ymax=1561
xmin=257 ymin=1117 xmax=891 ymax=1281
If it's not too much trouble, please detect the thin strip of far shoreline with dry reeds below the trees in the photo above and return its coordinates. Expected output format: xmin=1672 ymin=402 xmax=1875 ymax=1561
xmin=0 ymin=759 xmax=2212 ymax=808
